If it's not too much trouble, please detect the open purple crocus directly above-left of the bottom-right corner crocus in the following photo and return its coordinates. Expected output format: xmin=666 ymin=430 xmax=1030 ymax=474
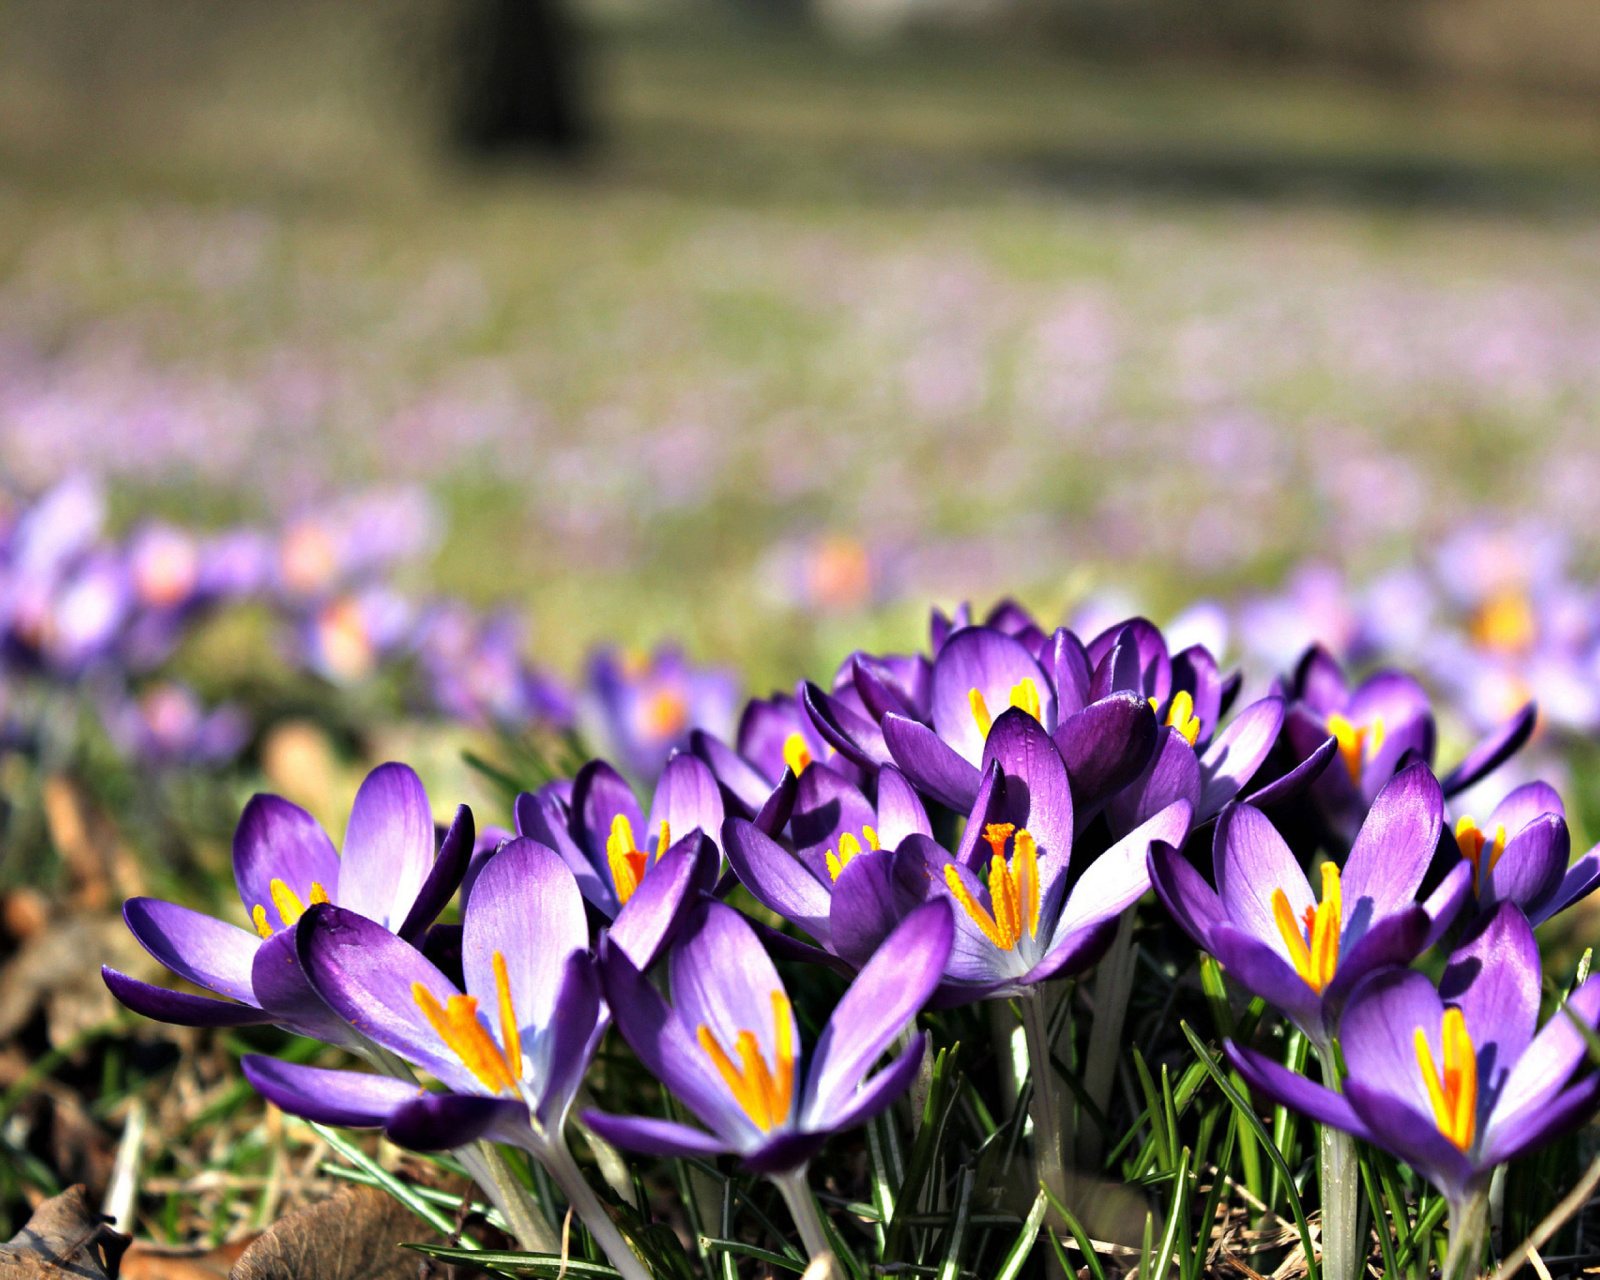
xmin=1150 ymin=763 xmax=1472 ymax=1050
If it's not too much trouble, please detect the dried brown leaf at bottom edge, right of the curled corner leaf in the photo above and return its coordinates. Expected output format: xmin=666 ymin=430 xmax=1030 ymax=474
xmin=225 ymin=1187 xmax=438 ymax=1280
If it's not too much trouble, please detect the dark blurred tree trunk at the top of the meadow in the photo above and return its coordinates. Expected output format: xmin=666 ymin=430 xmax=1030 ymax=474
xmin=454 ymin=0 xmax=594 ymax=155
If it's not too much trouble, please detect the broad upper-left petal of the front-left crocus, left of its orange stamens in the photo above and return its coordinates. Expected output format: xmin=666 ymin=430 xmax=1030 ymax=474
xmin=296 ymin=904 xmax=483 ymax=1093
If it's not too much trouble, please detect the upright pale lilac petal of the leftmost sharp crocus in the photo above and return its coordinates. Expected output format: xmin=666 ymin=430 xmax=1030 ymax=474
xmin=338 ymin=763 xmax=434 ymax=930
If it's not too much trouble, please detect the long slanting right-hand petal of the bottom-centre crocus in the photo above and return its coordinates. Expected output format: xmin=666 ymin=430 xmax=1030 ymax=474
xmin=806 ymin=901 xmax=955 ymax=1123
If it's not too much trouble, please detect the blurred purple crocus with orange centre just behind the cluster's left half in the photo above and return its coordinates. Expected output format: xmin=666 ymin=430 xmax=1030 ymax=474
xmin=589 ymin=645 xmax=736 ymax=778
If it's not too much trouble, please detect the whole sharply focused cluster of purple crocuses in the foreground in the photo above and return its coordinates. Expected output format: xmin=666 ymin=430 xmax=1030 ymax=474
xmin=107 ymin=603 xmax=1600 ymax=1280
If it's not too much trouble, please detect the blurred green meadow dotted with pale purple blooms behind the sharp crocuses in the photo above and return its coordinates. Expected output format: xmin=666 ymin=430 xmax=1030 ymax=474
xmin=0 ymin=0 xmax=1600 ymax=688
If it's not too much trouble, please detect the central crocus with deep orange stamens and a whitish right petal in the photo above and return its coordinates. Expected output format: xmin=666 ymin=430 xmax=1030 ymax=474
xmin=896 ymin=709 xmax=1190 ymax=1003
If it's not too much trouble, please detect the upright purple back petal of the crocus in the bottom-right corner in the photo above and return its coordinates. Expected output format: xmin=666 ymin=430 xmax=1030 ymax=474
xmin=1438 ymin=902 xmax=1539 ymax=1068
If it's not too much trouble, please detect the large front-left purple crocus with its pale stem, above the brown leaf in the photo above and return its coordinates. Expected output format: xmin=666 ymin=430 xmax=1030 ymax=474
xmin=242 ymin=838 xmax=650 ymax=1280
